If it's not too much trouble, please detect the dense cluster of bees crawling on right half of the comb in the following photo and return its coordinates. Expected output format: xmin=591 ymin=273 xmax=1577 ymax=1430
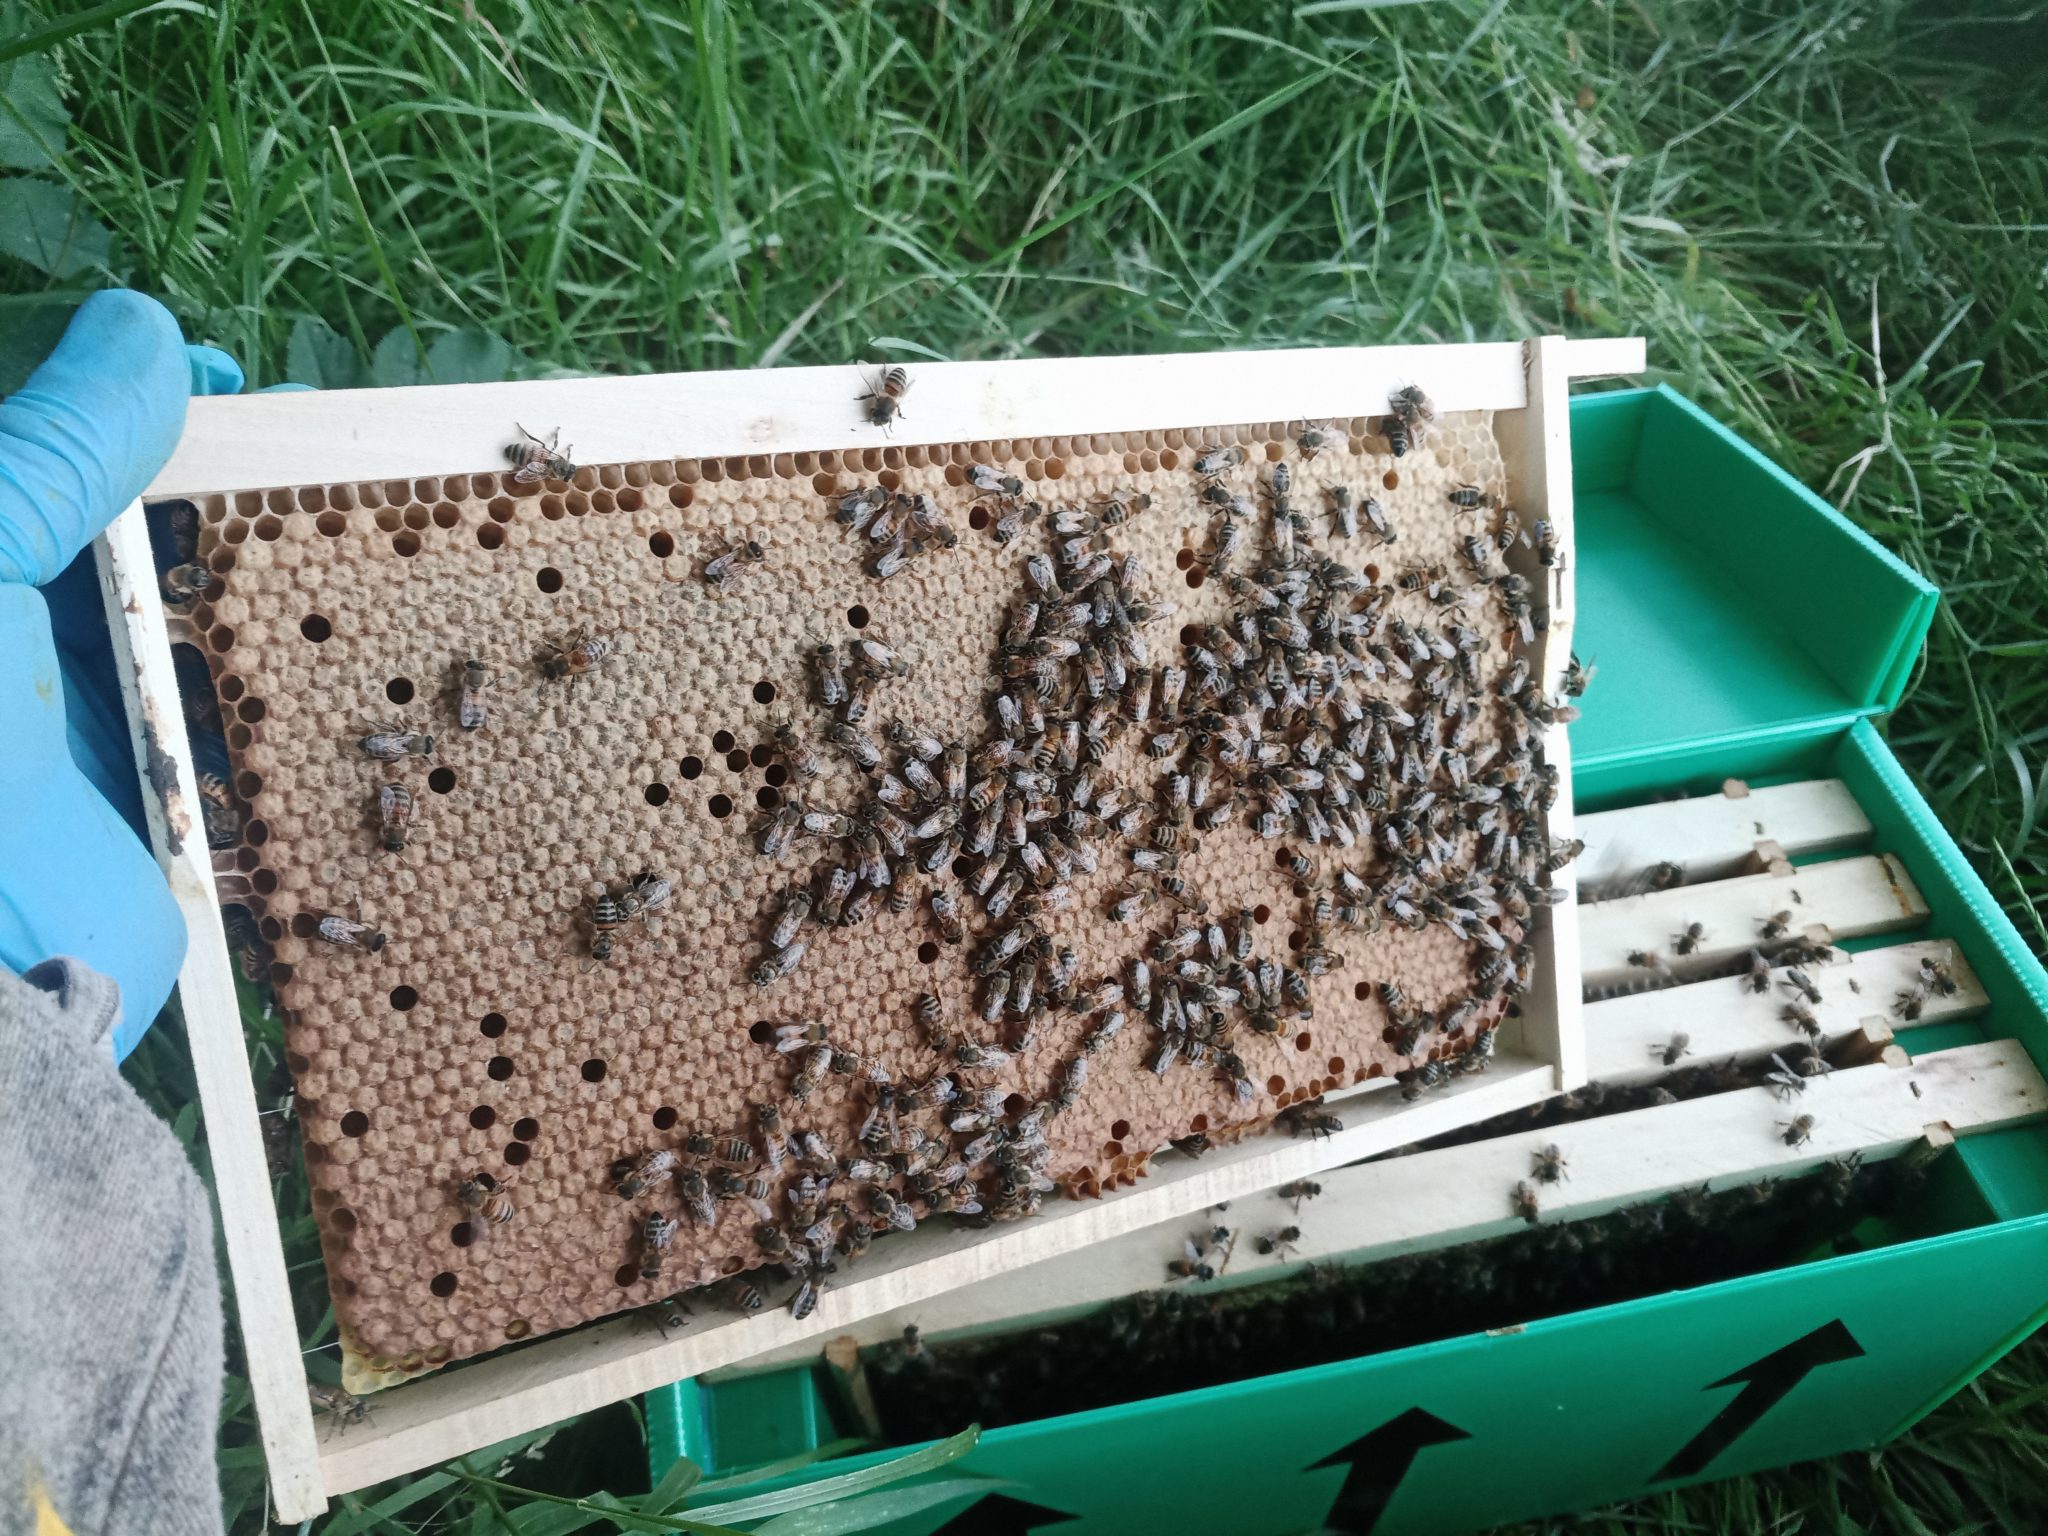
xmin=552 ymin=382 xmax=1577 ymax=1317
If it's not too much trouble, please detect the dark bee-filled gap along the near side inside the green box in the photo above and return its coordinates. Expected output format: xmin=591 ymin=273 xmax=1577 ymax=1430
xmin=864 ymin=1146 xmax=1925 ymax=1444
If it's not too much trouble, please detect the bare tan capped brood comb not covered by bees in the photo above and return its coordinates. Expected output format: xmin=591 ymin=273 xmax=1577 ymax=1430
xmin=176 ymin=414 xmax=1518 ymax=1378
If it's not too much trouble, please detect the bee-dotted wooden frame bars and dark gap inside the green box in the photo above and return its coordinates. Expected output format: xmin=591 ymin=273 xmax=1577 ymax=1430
xmin=700 ymin=778 xmax=2048 ymax=1442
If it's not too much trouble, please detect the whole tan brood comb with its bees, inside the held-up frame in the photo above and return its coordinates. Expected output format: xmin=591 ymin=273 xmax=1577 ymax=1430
xmin=163 ymin=399 xmax=1548 ymax=1378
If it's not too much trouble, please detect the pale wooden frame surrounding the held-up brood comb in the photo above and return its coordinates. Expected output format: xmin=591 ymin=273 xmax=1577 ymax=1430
xmin=94 ymin=336 xmax=1645 ymax=1522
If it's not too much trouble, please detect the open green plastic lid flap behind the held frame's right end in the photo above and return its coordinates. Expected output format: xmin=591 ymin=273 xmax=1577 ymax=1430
xmin=1571 ymin=387 xmax=1939 ymax=772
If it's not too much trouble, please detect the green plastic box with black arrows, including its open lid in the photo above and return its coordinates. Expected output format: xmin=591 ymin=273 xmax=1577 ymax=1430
xmin=647 ymin=389 xmax=2048 ymax=1536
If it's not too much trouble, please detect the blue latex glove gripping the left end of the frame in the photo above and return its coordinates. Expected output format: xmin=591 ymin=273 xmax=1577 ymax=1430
xmin=0 ymin=291 xmax=242 ymax=1057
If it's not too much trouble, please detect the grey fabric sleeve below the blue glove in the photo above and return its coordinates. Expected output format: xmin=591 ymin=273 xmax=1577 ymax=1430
xmin=0 ymin=961 xmax=221 ymax=1536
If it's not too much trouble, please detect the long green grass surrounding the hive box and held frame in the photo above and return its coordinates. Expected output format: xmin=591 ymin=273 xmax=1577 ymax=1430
xmin=16 ymin=0 xmax=2048 ymax=1532
